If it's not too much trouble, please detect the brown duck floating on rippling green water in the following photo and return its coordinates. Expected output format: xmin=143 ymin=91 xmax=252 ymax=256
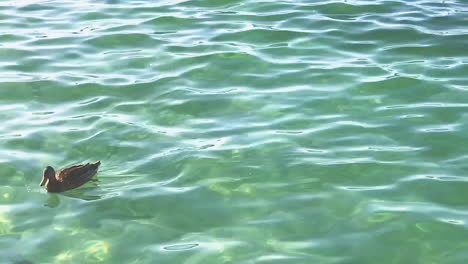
xmin=40 ymin=161 xmax=101 ymax=193
